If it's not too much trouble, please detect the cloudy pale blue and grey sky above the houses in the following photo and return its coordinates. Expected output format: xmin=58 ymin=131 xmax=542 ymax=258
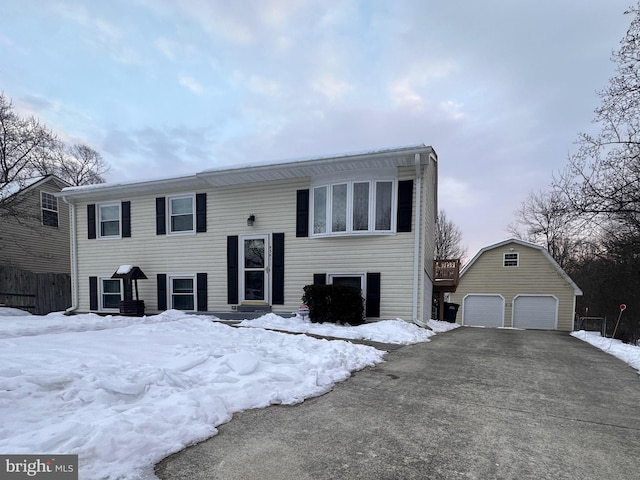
xmin=0 ymin=0 xmax=632 ymax=257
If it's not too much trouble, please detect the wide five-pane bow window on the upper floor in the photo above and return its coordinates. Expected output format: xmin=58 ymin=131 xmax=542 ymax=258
xmin=311 ymin=180 xmax=396 ymax=236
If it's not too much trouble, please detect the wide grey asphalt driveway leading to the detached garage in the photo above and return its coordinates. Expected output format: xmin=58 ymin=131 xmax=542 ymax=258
xmin=156 ymin=328 xmax=640 ymax=480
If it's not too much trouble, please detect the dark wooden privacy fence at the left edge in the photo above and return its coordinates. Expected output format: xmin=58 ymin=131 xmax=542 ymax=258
xmin=0 ymin=265 xmax=71 ymax=315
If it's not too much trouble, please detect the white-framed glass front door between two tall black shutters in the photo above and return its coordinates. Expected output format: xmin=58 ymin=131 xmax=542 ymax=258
xmin=240 ymin=235 xmax=269 ymax=304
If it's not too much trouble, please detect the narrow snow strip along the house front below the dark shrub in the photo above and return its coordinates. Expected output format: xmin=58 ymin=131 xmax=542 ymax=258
xmin=240 ymin=313 xmax=445 ymax=345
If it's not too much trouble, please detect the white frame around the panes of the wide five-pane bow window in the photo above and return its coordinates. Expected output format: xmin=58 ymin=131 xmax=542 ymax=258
xmin=309 ymin=176 xmax=398 ymax=237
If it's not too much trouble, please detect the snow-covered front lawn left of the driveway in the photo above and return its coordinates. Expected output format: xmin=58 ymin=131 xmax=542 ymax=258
xmin=0 ymin=308 xmax=454 ymax=480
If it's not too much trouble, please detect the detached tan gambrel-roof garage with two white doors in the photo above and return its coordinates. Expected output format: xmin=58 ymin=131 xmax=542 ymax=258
xmin=450 ymin=239 xmax=582 ymax=331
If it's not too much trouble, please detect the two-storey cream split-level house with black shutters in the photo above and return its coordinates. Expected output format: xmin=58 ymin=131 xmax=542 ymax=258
xmin=60 ymin=145 xmax=437 ymax=321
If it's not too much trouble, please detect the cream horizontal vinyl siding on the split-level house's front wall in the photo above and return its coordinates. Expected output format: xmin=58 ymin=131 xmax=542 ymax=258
xmin=76 ymin=174 xmax=422 ymax=320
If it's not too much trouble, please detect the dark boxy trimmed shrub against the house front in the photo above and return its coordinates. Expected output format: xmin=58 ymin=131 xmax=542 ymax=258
xmin=302 ymin=285 xmax=364 ymax=325
